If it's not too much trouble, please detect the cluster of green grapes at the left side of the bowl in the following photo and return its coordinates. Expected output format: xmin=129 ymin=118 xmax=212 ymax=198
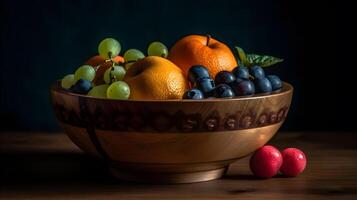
xmin=61 ymin=38 xmax=168 ymax=99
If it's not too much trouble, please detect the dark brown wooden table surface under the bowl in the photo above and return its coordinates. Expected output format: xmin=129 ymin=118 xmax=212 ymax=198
xmin=0 ymin=132 xmax=357 ymax=200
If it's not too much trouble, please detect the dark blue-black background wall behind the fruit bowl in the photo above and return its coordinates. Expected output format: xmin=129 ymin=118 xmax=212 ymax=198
xmin=0 ymin=0 xmax=356 ymax=131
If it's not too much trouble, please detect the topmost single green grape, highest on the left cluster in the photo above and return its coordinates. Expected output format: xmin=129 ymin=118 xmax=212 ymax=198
xmin=98 ymin=38 xmax=121 ymax=59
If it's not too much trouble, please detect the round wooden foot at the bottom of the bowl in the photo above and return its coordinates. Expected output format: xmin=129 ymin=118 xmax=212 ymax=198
xmin=110 ymin=166 xmax=228 ymax=184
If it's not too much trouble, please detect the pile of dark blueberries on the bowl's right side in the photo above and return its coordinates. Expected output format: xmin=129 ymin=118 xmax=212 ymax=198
xmin=183 ymin=65 xmax=282 ymax=99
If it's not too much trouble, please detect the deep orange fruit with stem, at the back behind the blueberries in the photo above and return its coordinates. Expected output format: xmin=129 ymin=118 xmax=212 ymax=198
xmin=168 ymin=35 xmax=238 ymax=78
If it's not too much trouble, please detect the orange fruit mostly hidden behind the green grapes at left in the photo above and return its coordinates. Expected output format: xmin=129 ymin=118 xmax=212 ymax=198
xmin=85 ymin=55 xmax=124 ymax=85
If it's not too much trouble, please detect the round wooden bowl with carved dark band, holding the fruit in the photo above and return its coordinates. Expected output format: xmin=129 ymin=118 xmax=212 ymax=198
xmin=51 ymin=82 xmax=293 ymax=183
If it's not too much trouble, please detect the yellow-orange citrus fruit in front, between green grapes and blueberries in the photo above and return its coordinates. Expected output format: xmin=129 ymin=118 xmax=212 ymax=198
xmin=124 ymin=56 xmax=187 ymax=100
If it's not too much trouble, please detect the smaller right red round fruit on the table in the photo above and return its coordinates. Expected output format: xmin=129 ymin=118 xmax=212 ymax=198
xmin=280 ymin=148 xmax=306 ymax=176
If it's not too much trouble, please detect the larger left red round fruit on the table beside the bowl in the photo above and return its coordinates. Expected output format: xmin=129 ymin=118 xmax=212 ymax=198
xmin=250 ymin=145 xmax=283 ymax=178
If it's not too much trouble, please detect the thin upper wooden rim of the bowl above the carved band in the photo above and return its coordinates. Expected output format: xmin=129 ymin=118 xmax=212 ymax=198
xmin=50 ymin=80 xmax=294 ymax=103
